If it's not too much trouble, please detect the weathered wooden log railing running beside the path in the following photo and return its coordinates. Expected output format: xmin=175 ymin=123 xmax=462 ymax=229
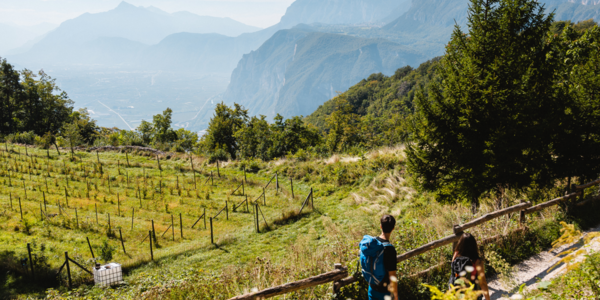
xmin=230 ymin=179 xmax=600 ymax=300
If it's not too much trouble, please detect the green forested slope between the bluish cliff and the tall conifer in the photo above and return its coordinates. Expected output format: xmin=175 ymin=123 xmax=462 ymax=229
xmin=305 ymin=58 xmax=439 ymax=147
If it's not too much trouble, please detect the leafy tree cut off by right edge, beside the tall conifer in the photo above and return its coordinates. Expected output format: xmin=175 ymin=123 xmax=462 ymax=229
xmin=553 ymin=25 xmax=600 ymax=184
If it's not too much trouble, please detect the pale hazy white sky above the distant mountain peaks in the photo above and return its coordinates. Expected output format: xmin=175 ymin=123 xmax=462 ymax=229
xmin=0 ymin=0 xmax=294 ymax=28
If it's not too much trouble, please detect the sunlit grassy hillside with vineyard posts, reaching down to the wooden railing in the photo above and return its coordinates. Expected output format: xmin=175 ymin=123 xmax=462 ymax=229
xmin=0 ymin=146 xmax=600 ymax=299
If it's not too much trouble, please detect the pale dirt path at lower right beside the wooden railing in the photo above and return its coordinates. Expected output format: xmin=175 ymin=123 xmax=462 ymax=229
xmin=488 ymin=226 xmax=600 ymax=300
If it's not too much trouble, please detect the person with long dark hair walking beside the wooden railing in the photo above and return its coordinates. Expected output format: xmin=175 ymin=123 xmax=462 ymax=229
xmin=450 ymin=233 xmax=490 ymax=300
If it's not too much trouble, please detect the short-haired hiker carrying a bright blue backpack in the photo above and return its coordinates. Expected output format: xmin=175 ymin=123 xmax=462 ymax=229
xmin=360 ymin=215 xmax=398 ymax=300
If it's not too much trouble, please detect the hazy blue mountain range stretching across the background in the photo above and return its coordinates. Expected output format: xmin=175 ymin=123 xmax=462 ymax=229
xmin=7 ymin=0 xmax=600 ymax=130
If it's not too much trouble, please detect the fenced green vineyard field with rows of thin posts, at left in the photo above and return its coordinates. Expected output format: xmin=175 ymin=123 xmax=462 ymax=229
xmin=0 ymin=146 xmax=318 ymax=294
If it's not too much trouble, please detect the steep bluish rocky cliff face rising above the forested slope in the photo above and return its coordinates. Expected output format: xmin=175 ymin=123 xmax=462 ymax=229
xmin=224 ymin=28 xmax=425 ymax=117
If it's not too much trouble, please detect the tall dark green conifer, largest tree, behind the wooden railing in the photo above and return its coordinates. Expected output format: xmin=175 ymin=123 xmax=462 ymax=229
xmin=407 ymin=0 xmax=565 ymax=207
